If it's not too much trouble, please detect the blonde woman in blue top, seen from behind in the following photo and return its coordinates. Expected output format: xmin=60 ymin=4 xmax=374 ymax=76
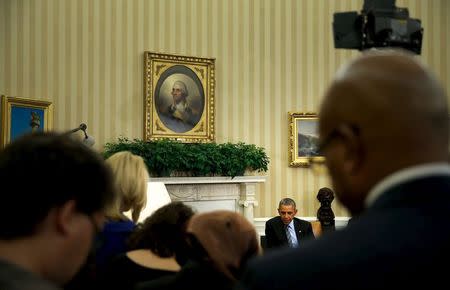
xmin=96 ymin=151 xmax=149 ymax=270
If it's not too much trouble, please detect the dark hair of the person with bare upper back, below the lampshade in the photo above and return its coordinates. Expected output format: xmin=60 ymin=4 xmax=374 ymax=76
xmin=129 ymin=201 xmax=195 ymax=257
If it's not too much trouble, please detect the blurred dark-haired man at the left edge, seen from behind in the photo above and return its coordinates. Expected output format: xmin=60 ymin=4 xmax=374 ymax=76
xmin=0 ymin=133 xmax=114 ymax=290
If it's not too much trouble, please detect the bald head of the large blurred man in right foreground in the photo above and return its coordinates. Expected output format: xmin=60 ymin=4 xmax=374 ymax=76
xmin=319 ymin=51 xmax=449 ymax=211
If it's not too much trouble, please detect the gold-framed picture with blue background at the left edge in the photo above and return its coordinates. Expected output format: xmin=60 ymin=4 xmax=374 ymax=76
xmin=0 ymin=95 xmax=53 ymax=147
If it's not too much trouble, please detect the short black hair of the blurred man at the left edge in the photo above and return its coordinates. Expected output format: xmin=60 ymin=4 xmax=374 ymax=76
xmin=0 ymin=132 xmax=114 ymax=239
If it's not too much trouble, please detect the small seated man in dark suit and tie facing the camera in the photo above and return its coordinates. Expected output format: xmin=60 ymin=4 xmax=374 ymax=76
xmin=265 ymin=198 xmax=314 ymax=249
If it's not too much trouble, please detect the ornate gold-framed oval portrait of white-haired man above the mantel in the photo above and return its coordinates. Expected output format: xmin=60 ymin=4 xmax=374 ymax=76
xmin=144 ymin=51 xmax=215 ymax=143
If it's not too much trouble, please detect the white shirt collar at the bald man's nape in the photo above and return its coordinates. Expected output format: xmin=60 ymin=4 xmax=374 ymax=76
xmin=365 ymin=162 xmax=450 ymax=207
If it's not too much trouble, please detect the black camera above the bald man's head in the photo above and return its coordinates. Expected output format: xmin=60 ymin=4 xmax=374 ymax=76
xmin=333 ymin=0 xmax=423 ymax=54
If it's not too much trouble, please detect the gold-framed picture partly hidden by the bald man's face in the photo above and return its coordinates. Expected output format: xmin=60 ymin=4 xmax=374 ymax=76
xmin=289 ymin=112 xmax=325 ymax=167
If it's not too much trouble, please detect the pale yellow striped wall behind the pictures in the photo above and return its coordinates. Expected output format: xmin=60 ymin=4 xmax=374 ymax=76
xmin=0 ymin=0 xmax=450 ymax=217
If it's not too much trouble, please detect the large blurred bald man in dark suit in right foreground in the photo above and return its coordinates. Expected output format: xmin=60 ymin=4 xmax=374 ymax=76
xmin=241 ymin=51 xmax=450 ymax=290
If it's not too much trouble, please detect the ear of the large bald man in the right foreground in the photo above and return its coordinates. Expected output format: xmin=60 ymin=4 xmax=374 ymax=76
xmin=338 ymin=125 xmax=364 ymax=175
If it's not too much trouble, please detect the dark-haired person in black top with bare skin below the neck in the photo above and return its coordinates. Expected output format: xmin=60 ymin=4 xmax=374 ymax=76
xmin=98 ymin=201 xmax=195 ymax=290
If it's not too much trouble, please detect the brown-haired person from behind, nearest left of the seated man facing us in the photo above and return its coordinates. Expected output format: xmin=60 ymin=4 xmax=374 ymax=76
xmin=140 ymin=210 xmax=260 ymax=290
